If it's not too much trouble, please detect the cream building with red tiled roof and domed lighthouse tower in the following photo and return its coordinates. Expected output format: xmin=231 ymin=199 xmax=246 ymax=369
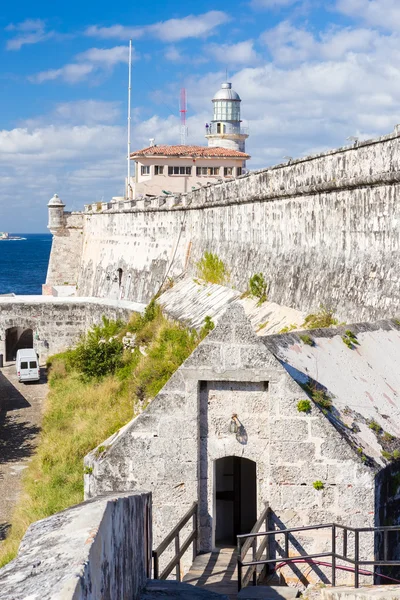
xmin=129 ymin=83 xmax=250 ymax=198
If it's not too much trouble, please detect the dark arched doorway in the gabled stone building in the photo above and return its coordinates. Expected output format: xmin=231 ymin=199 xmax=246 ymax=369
xmin=215 ymin=456 xmax=257 ymax=546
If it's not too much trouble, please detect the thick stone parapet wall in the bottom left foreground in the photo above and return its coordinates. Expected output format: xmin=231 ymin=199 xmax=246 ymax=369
xmin=0 ymin=492 xmax=152 ymax=600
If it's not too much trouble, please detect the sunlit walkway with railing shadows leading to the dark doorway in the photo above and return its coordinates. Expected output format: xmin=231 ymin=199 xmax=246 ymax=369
xmin=183 ymin=548 xmax=237 ymax=600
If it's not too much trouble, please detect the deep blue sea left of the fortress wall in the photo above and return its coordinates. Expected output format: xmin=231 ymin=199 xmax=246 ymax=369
xmin=0 ymin=233 xmax=52 ymax=294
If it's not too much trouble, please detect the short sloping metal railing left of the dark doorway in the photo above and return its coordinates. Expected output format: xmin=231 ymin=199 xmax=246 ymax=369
xmin=153 ymin=502 xmax=198 ymax=581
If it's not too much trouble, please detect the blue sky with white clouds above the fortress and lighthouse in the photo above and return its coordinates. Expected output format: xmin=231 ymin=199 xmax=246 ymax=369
xmin=0 ymin=0 xmax=400 ymax=232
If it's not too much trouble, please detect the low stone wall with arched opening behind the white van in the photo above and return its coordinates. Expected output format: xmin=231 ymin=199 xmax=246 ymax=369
xmin=0 ymin=296 xmax=144 ymax=361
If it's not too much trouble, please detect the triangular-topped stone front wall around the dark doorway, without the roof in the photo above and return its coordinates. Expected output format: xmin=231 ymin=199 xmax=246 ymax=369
xmin=85 ymin=305 xmax=375 ymax=579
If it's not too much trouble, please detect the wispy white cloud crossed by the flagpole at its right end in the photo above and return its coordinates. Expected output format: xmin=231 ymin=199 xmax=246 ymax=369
xmin=29 ymin=46 xmax=133 ymax=83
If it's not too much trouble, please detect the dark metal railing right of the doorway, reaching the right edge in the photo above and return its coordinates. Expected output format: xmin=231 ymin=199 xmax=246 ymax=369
xmin=237 ymin=523 xmax=400 ymax=591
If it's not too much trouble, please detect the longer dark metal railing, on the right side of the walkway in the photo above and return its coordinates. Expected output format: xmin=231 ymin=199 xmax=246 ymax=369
xmin=237 ymin=517 xmax=400 ymax=591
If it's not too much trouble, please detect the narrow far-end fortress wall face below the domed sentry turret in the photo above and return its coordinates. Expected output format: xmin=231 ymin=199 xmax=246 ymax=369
xmin=43 ymin=213 xmax=84 ymax=293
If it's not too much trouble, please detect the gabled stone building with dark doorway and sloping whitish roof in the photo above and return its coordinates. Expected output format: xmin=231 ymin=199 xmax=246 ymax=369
xmin=85 ymin=304 xmax=400 ymax=581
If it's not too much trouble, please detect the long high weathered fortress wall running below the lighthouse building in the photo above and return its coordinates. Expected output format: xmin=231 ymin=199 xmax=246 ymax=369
xmin=47 ymin=130 xmax=400 ymax=320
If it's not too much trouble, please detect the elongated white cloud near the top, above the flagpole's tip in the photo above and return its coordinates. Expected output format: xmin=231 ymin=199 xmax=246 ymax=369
xmin=86 ymin=10 xmax=230 ymax=42
